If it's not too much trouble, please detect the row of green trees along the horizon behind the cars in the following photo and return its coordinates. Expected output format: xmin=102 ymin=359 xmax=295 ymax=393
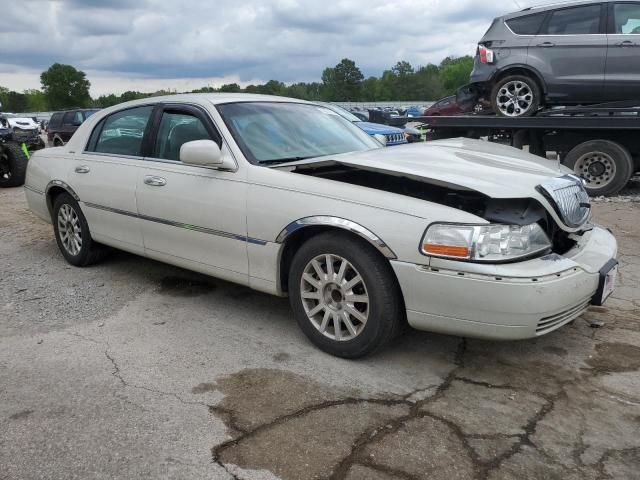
xmin=0 ymin=56 xmax=473 ymax=112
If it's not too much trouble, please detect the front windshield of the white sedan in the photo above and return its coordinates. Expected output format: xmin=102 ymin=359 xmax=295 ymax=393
xmin=218 ymin=102 xmax=381 ymax=164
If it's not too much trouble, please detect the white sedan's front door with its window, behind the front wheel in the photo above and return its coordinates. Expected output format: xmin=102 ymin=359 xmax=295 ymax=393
xmin=137 ymin=105 xmax=249 ymax=283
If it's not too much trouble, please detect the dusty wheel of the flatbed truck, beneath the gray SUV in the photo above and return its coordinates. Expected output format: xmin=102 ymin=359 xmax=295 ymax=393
xmin=564 ymin=140 xmax=633 ymax=196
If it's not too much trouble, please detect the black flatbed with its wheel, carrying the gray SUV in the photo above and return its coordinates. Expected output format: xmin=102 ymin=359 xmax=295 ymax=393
xmin=414 ymin=101 xmax=640 ymax=196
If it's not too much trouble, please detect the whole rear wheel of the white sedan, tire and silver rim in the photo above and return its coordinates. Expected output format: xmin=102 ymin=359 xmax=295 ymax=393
xmin=51 ymin=193 xmax=108 ymax=267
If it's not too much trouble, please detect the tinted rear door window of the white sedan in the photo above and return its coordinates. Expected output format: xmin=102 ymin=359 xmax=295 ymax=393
xmin=89 ymin=106 xmax=153 ymax=157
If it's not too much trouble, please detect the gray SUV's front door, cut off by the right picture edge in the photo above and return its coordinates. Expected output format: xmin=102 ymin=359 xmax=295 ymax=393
xmin=605 ymin=2 xmax=640 ymax=101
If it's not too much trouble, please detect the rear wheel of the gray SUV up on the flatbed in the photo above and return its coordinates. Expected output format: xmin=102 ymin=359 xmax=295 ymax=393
xmin=491 ymin=75 xmax=542 ymax=117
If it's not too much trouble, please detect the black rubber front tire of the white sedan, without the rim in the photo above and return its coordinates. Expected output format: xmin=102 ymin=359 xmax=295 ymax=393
xmin=289 ymin=232 xmax=406 ymax=359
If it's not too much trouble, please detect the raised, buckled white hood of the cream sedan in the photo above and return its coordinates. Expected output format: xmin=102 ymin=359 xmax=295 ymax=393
xmin=282 ymin=138 xmax=570 ymax=203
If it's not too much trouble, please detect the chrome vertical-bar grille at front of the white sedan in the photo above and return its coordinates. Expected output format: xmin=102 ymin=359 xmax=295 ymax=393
xmin=540 ymin=175 xmax=591 ymax=228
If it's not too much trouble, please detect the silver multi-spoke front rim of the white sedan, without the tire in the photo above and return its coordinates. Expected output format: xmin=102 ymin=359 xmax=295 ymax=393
xmin=300 ymin=254 xmax=369 ymax=342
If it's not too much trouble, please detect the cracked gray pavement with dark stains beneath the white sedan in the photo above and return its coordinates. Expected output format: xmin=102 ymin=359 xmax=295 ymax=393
xmin=0 ymin=185 xmax=640 ymax=480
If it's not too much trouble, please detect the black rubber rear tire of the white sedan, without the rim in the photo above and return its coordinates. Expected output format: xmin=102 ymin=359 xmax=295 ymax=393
xmin=51 ymin=193 xmax=108 ymax=267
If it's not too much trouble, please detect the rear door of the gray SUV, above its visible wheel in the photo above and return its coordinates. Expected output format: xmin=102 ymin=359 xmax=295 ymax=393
xmin=529 ymin=3 xmax=607 ymax=104
